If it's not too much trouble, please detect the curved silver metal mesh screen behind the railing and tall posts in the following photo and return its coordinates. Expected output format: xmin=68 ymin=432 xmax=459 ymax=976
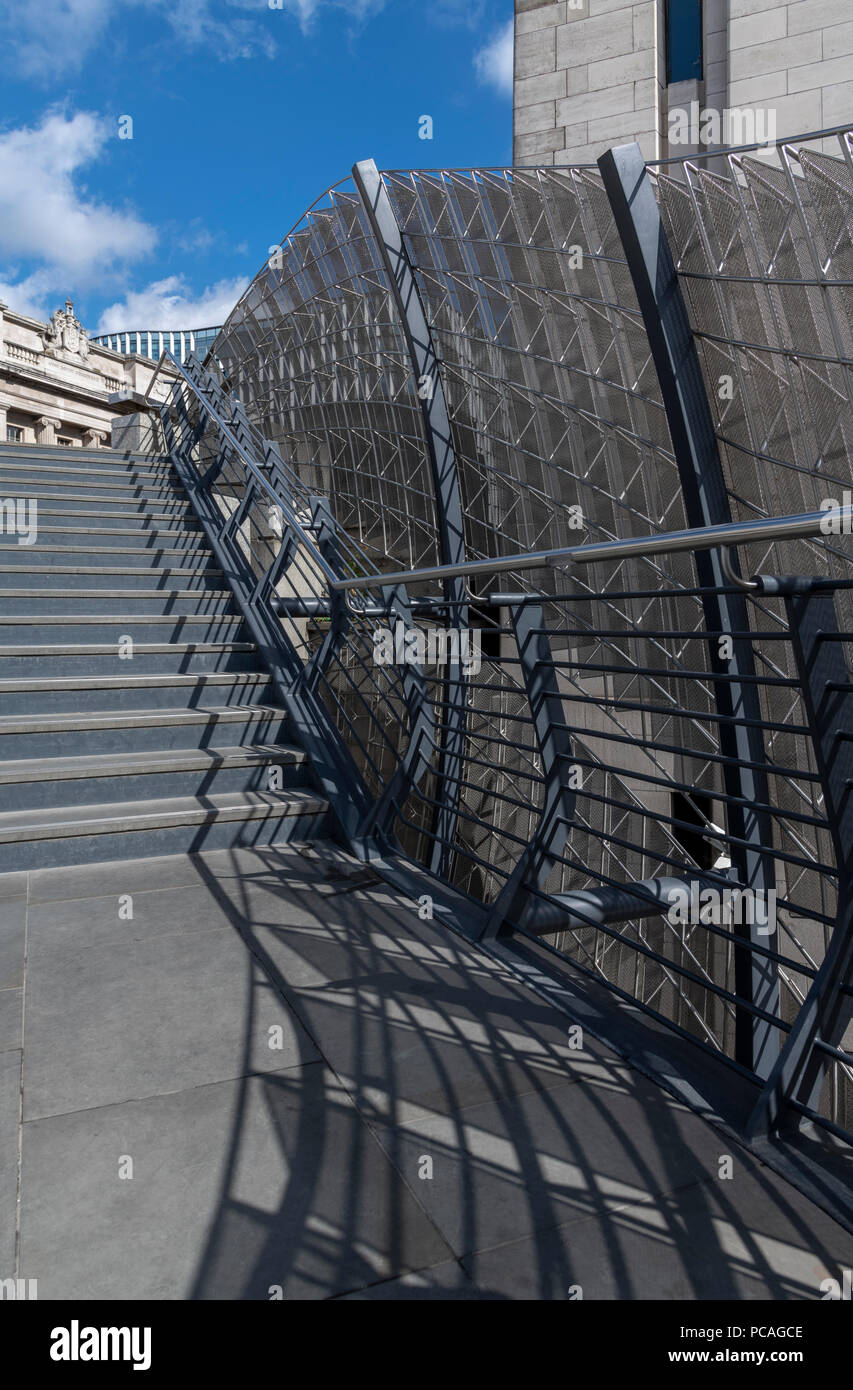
xmin=213 ymin=133 xmax=853 ymax=1116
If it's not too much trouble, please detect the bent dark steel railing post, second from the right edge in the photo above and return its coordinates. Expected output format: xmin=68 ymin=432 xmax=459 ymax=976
xmin=482 ymin=594 xmax=575 ymax=938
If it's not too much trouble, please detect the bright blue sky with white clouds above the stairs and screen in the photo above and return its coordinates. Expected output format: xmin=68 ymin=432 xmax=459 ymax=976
xmin=0 ymin=0 xmax=513 ymax=332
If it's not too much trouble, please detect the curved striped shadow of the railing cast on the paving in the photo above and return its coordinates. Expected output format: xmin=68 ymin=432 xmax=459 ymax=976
xmin=175 ymin=849 xmax=850 ymax=1300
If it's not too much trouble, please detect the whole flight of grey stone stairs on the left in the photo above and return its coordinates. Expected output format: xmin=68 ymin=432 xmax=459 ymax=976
xmin=0 ymin=445 xmax=328 ymax=873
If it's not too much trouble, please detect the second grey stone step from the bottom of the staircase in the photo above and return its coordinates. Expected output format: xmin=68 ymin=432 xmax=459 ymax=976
xmin=0 ymin=744 xmax=307 ymax=810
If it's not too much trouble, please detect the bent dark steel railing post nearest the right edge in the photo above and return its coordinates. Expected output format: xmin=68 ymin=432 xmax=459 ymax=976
xmin=749 ymin=580 xmax=853 ymax=1138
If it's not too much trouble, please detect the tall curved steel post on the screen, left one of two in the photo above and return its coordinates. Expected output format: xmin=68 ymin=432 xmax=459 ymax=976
xmin=353 ymin=160 xmax=468 ymax=877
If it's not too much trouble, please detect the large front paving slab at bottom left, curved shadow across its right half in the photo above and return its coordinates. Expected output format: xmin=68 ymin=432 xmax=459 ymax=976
xmin=21 ymin=1063 xmax=450 ymax=1300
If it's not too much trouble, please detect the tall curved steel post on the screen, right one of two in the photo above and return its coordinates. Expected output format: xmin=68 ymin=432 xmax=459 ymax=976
xmin=599 ymin=145 xmax=779 ymax=1077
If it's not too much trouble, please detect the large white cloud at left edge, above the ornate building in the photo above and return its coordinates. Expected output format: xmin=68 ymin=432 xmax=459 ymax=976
xmin=0 ymin=111 xmax=157 ymax=286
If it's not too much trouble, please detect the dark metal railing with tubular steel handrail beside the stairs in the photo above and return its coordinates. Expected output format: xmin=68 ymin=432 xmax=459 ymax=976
xmin=163 ymin=347 xmax=853 ymax=1150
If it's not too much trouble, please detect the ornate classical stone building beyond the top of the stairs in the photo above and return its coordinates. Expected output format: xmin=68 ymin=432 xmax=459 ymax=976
xmin=0 ymin=300 xmax=170 ymax=448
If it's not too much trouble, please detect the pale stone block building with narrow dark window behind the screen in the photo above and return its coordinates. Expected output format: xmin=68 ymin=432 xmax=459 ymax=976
xmin=513 ymin=0 xmax=853 ymax=164
